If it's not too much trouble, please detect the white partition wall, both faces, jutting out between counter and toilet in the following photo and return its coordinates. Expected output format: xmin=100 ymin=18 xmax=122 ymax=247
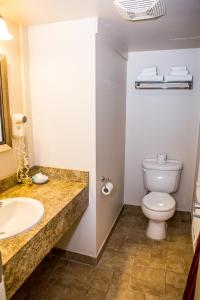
xmin=28 ymin=19 xmax=126 ymax=257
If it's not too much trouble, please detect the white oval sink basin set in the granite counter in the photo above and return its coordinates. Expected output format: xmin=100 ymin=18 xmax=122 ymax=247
xmin=0 ymin=197 xmax=44 ymax=240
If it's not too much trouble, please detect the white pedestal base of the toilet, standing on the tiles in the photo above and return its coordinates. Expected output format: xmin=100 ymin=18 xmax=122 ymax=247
xmin=146 ymin=220 xmax=167 ymax=240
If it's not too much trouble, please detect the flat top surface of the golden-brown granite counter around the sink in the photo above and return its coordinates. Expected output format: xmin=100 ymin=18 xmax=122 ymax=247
xmin=0 ymin=179 xmax=87 ymax=265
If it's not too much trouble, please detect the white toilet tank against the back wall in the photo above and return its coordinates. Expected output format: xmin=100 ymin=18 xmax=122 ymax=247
xmin=142 ymin=159 xmax=183 ymax=194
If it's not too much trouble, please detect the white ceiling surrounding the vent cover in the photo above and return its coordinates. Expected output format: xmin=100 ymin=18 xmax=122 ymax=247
xmin=0 ymin=0 xmax=200 ymax=51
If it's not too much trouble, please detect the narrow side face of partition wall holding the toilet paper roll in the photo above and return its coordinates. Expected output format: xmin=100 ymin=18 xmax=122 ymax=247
xmin=96 ymin=35 xmax=126 ymax=251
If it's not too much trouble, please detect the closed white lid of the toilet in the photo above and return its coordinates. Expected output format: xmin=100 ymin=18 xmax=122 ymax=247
xmin=143 ymin=192 xmax=176 ymax=211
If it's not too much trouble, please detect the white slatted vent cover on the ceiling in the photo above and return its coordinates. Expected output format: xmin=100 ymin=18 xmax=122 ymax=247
xmin=113 ymin=0 xmax=165 ymax=21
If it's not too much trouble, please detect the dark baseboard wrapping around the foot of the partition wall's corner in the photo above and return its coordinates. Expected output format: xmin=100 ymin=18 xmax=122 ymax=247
xmin=50 ymin=206 xmax=124 ymax=265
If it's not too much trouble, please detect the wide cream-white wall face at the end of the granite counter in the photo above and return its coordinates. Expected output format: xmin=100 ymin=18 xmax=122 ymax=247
xmin=28 ymin=19 xmax=97 ymax=256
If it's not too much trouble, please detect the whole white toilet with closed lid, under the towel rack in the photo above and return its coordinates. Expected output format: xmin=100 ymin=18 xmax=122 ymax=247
xmin=142 ymin=159 xmax=183 ymax=240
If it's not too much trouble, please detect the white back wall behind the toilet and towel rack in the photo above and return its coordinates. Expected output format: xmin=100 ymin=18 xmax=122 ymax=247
xmin=124 ymin=49 xmax=200 ymax=211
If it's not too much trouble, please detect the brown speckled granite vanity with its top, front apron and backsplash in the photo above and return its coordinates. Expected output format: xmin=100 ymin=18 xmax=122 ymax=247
xmin=0 ymin=168 xmax=88 ymax=299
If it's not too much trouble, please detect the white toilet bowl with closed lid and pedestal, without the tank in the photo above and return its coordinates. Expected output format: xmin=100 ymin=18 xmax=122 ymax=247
xmin=142 ymin=192 xmax=176 ymax=240
